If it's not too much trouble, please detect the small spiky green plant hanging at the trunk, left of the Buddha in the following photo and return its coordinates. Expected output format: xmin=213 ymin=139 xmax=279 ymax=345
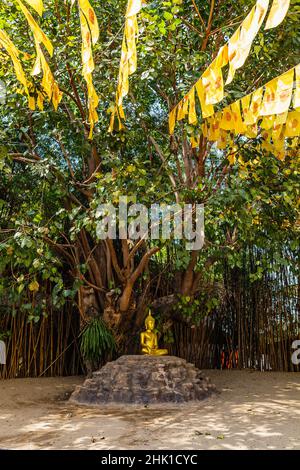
xmin=80 ymin=317 xmax=116 ymax=362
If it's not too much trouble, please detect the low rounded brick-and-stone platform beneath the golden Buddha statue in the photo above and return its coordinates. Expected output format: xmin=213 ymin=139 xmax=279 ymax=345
xmin=70 ymin=356 xmax=215 ymax=405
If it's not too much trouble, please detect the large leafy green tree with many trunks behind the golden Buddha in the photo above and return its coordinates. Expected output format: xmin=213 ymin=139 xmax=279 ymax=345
xmin=0 ymin=0 xmax=299 ymax=352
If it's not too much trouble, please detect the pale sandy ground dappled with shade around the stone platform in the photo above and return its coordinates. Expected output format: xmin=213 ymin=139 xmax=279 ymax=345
xmin=0 ymin=371 xmax=300 ymax=450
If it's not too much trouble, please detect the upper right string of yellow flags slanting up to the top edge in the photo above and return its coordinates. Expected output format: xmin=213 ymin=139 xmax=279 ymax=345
xmin=169 ymin=0 xmax=290 ymax=135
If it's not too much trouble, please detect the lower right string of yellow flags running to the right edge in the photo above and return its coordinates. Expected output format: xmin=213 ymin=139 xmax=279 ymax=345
xmin=196 ymin=64 xmax=300 ymax=160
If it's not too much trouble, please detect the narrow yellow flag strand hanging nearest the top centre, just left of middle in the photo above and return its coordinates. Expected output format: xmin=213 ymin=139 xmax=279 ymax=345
xmin=108 ymin=0 xmax=142 ymax=132
